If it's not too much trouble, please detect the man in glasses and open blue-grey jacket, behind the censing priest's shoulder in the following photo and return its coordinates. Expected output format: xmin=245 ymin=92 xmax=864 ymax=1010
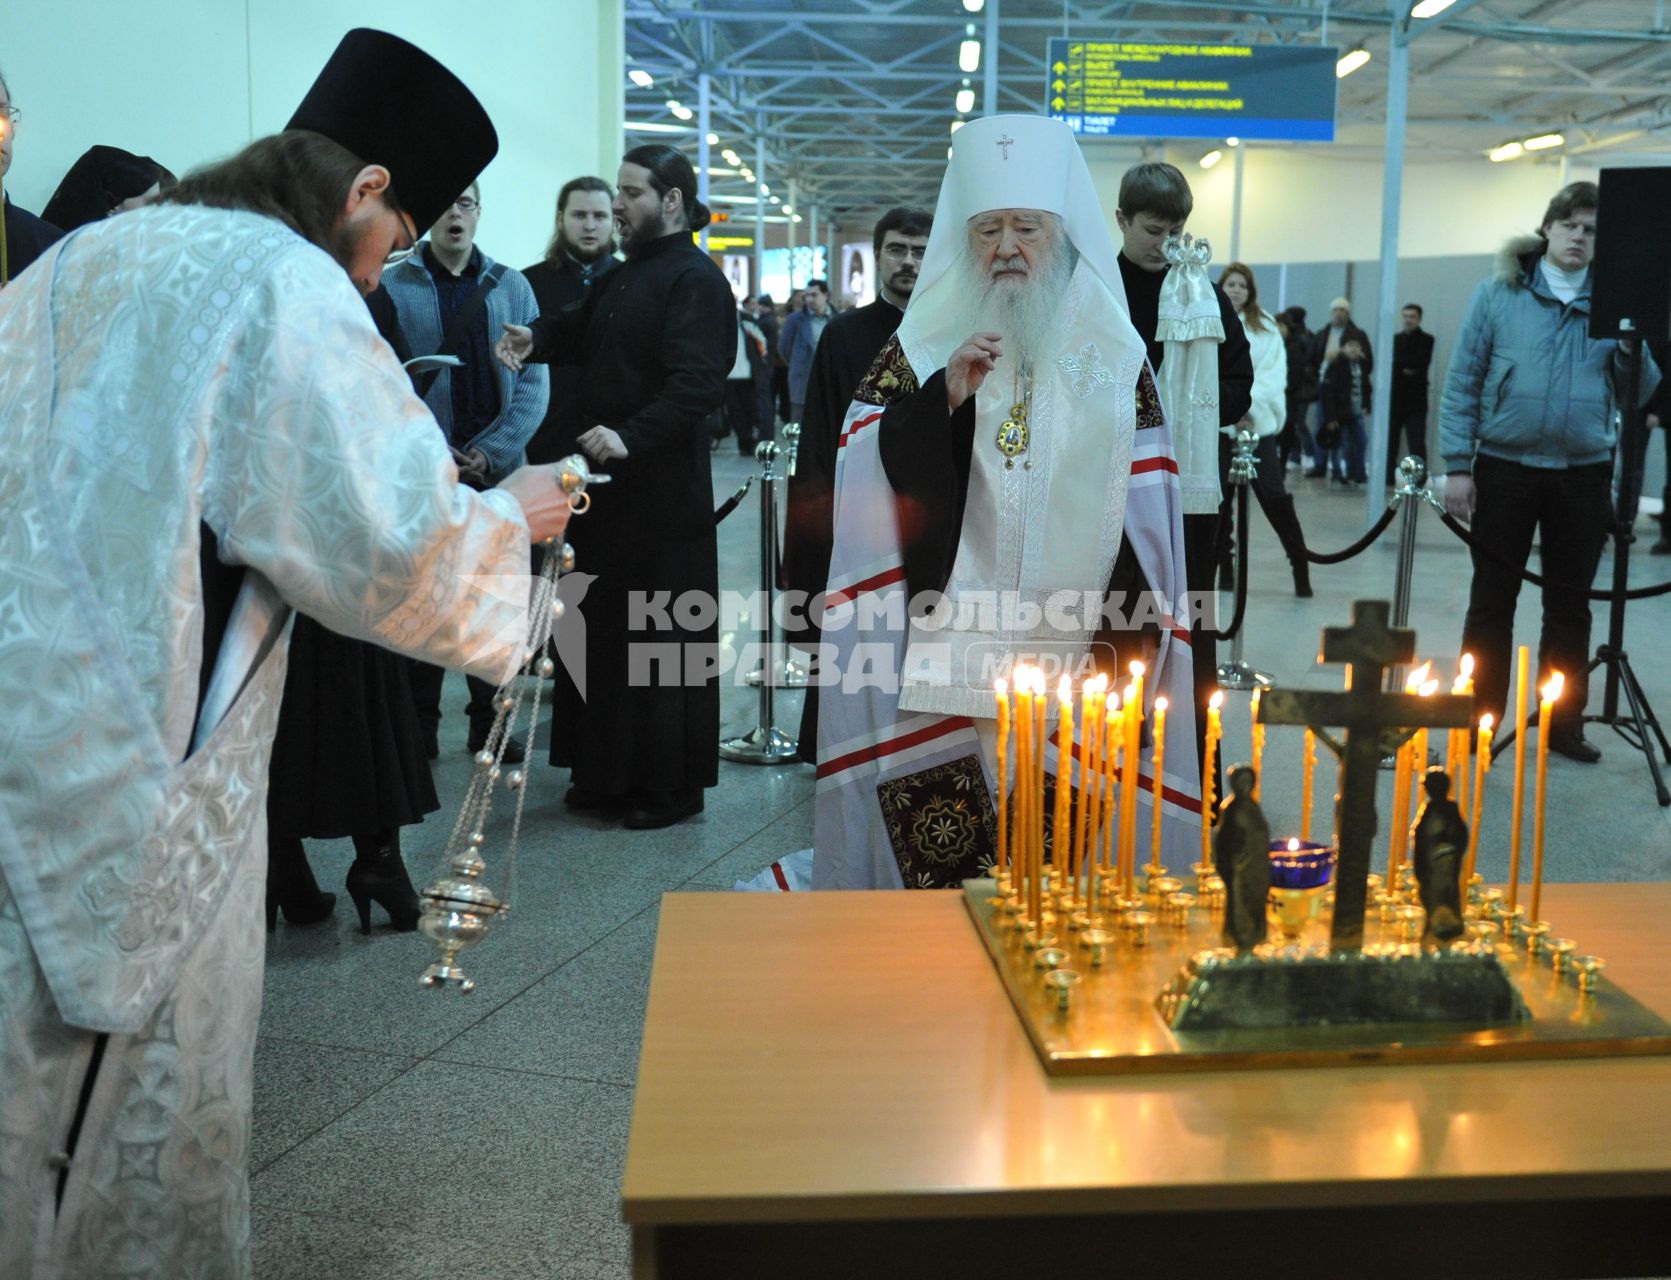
xmin=383 ymin=182 xmax=550 ymax=764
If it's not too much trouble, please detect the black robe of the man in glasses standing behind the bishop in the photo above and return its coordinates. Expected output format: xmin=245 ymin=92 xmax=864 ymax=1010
xmin=782 ymin=297 xmax=906 ymax=764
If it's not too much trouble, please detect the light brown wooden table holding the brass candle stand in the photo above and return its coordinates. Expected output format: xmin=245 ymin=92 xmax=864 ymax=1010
xmin=622 ymin=884 xmax=1671 ymax=1280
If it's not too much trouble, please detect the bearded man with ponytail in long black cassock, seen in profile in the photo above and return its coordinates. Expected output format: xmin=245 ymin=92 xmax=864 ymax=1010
xmin=496 ymin=144 xmax=737 ymax=829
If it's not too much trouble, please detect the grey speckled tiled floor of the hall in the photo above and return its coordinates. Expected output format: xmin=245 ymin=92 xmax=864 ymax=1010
xmin=252 ymin=453 xmax=1671 ymax=1280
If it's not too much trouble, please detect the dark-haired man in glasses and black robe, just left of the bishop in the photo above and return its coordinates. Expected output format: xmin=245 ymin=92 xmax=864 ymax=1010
xmin=784 ymin=206 xmax=934 ymax=764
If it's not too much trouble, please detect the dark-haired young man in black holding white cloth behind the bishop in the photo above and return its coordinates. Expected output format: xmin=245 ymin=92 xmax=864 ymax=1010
xmin=1115 ymin=164 xmax=1253 ymax=782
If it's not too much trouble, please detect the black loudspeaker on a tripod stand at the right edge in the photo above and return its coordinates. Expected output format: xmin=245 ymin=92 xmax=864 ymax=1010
xmin=1589 ymin=169 xmax=1671 ymax=338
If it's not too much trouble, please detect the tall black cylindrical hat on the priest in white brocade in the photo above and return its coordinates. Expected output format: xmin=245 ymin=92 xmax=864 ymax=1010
xmin=284 ymin=27 xmax=500 ymax=234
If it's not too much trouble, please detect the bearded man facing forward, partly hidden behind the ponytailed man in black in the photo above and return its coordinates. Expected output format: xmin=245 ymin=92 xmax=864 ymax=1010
xmin=523 ymin=177 xmax=622 ymax=463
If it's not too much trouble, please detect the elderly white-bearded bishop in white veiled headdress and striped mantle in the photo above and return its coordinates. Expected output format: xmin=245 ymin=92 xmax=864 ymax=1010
xmin=812 ymin=115 xmax=1200 ymax=889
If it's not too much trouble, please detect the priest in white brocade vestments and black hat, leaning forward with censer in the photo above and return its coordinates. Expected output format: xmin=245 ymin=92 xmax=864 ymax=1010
xmin=0 ymin=30 xmax=568 ymax=1280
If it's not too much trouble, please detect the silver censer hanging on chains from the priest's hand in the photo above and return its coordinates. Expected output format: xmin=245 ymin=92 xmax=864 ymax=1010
xmin=418 ymin=455 xmax=610 ymax=993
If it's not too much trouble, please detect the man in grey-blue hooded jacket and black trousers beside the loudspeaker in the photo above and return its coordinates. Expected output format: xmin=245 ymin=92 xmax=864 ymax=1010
xmin=1439 ymin=182 xmax=1659 ymax=764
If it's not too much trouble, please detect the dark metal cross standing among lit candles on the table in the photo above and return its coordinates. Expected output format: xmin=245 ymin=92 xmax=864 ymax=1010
xmin=1258 ymin=600 xmax=1474 ymax=951
